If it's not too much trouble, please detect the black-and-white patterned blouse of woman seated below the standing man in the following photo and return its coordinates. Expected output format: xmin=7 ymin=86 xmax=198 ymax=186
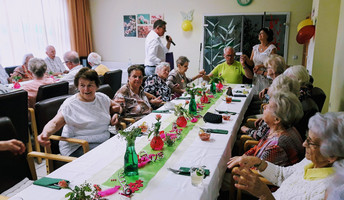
xmin=144 ymin=74 xmax=171 ymax=102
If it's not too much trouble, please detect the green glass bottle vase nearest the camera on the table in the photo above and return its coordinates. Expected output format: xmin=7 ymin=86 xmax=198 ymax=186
xmin=124 ymin=140 xmax=139 ymax=176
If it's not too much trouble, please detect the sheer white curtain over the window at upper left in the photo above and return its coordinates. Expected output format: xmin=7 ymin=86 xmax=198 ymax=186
xmin=0 ymin=0 xmax=71 ymax=67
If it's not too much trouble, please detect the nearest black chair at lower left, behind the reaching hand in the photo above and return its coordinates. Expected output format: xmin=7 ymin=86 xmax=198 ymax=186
xmin=0 ymin=117 xmax=32 ymax=193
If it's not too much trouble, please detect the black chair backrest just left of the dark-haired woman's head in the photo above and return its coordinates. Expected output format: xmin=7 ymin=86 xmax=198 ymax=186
xmin=36 ymin=81 xmax=69 ymax=102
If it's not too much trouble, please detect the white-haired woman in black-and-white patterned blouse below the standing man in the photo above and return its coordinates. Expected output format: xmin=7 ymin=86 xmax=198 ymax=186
xmin=144 ymin=62 xmax=171 ymax=102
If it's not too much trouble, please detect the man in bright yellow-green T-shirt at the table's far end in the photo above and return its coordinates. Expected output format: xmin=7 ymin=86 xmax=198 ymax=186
xmin=203 ymin=47 xmax=253 ymax=84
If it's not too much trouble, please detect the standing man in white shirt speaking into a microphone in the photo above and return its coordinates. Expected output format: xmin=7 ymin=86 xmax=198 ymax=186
xmin=145 ymin=19 xmax=175 ymax=76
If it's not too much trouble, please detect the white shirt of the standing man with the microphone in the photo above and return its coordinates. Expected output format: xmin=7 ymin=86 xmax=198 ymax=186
xmin=145 ymin=30 xmax=168 ymax=66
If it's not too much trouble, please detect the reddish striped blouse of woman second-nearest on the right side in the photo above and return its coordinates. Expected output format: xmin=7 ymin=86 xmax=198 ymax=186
xmin=245 ymin=127 xmax=304 ymax=166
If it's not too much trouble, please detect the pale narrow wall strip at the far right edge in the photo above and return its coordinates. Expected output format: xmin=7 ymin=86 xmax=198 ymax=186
xmin=329 ymin=0 xmax=344 ymax=111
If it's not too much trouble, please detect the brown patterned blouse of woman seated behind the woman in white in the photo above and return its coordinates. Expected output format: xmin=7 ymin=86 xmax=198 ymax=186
xmin=114 ymin=83 xmax=152 ymax=120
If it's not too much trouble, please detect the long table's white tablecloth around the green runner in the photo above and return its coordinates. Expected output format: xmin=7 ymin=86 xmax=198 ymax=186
xmin=14 ymin=84 xmax=252 ymax=200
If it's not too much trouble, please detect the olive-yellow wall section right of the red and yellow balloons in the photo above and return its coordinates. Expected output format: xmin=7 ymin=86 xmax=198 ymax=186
xmin=312 ymin=0 xmax=343 ymax=113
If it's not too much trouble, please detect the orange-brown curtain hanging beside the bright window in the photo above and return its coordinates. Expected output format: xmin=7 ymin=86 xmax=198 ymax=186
xmin=67 ymin=0 xmax=93 ymax=56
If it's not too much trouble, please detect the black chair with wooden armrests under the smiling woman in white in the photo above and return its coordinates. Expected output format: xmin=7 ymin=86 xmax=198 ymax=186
xmin=28 ymin=95 xmax=89 ymax=176
